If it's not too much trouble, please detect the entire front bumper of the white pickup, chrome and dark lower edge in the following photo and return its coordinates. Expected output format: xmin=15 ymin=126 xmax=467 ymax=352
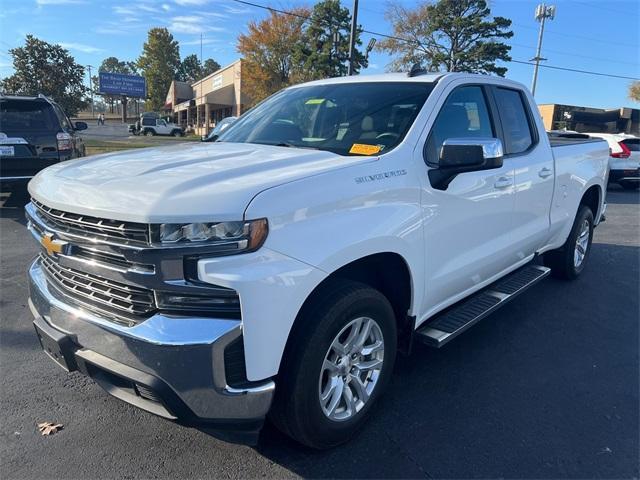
xmin=29 ymin=260 xmax=275 ymax=443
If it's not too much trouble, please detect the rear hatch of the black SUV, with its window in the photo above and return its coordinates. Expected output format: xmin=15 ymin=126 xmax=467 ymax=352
xmin=0 ymin=99 xmax=60 ymax=179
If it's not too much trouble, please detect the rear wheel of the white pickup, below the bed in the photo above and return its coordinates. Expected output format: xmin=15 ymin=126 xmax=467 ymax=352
xmin=544 ymin=205 xmax=593 ymax=280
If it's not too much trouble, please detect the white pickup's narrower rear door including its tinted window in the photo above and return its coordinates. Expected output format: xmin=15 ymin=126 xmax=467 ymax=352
xmin=491 ymin=86 xmax=555 ymax=260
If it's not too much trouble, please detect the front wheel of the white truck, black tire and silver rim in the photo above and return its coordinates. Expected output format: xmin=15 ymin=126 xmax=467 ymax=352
xmin=269 ymin=279 xmax=397 ymax=449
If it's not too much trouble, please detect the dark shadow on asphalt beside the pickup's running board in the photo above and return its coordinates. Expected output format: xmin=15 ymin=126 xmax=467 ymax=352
xmin=252 ymin=244 xmax=640 ymax=478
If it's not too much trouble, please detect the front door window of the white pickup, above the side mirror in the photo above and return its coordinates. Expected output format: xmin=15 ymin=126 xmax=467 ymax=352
xmin=425 ymin=85 xmax=495 ymax=164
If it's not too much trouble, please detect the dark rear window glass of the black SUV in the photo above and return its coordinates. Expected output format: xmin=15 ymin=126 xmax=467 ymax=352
xmin=0 ymin=100 xmax=60 ymax=134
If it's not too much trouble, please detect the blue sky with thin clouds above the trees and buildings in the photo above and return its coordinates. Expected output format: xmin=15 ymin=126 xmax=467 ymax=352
xmin=0 ymin=0 xmax=640 ymax=108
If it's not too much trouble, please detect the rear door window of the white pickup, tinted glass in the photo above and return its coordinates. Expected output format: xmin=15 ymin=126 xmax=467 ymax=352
xmin=495 ymin=88 xmax=533 ymax=155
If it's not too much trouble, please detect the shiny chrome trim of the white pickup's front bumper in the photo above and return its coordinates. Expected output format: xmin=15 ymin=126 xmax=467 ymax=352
xmin=29 ymin=261 xmax=275 ymax=419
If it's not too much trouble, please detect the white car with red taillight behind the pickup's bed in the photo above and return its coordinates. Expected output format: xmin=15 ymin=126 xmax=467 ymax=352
xmin=588 ymin=133 xmax=640 ymax=190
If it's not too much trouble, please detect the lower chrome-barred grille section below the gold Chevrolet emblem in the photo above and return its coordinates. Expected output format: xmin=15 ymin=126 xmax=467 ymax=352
xmin=40 ymin=254 xmax=156 ymax=323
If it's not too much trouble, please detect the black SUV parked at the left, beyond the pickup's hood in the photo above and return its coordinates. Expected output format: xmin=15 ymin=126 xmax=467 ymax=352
xmin=0 ymin=95 xmax=87 ymax=186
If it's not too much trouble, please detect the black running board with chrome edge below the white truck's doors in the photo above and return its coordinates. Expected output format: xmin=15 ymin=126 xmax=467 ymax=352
xmin=416 ymin=265 xmax=551 ymax=348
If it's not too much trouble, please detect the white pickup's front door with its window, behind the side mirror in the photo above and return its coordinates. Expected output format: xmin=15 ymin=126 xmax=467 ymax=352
xmin=422 ymin=85 xmax=515 ymax=317
